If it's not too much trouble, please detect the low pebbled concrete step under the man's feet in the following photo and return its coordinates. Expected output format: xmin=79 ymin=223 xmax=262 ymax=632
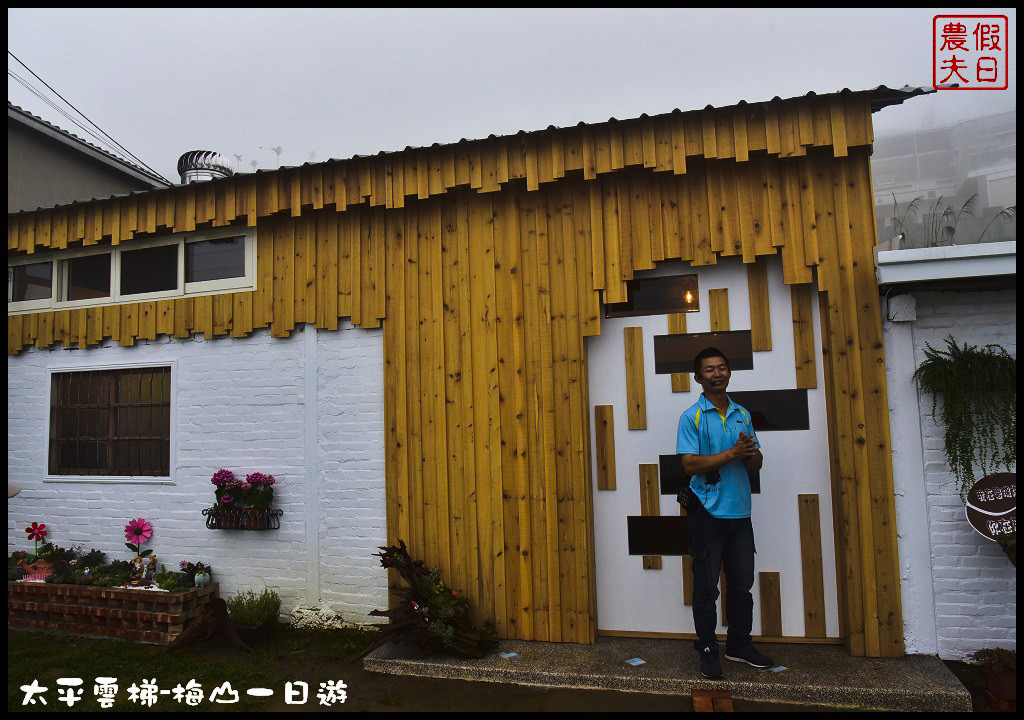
xmin=364 ymin=637 xmax=972 ymax=712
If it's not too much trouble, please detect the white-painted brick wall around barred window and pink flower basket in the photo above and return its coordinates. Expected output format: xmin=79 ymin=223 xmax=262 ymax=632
xmin=7 ymin=324 xmax=387 ymax=623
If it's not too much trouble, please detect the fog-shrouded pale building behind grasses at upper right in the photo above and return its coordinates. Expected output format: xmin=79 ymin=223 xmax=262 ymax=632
xmin=871 ymin=111 xmax=1017 ymax=247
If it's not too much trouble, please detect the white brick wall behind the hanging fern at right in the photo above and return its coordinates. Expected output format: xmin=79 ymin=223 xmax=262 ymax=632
xmin=882 ymin=290 xmax=1017 ymax=660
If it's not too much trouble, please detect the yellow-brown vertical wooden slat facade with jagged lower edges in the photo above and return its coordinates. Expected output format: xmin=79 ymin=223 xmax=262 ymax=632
xmin=7 ymin=93 xmax=903 ymax=655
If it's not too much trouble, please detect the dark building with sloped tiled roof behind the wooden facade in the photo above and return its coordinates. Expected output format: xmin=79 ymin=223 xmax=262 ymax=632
xmin=7 ymin=101 xmax=168 ymax=212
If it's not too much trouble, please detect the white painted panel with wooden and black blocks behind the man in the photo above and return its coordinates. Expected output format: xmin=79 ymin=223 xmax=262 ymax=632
xmin=587 ymin=257 xmax=839 ymax=637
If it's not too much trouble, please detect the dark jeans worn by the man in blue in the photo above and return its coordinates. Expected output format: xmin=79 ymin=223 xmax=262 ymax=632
xmin=686 ymin=492 xmax=754 ymax=652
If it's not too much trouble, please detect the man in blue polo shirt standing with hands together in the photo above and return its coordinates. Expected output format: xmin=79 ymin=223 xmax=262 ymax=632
xmin=676 ymin=347 xmax=773 ymax=678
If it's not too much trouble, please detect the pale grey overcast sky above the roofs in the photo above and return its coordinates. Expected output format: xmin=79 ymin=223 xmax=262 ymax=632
xmin=7 ymin=8 xmax=1018 ymax=181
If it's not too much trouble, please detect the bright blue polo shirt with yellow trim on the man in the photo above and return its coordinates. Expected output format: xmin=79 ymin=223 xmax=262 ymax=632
xmin=676 ymin=393 xmax=761 ymax=518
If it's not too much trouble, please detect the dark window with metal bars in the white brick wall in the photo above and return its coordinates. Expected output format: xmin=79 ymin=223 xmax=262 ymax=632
xmin=49 ymin=367 xmax=171 ymax=477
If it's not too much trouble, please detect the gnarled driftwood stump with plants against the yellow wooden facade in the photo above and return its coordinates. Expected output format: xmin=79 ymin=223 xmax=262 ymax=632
xmin=356 ymin=540 xmax=498 ymax=660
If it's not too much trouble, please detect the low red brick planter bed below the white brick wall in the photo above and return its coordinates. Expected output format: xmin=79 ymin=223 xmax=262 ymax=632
xmin=7 ymin=581 xmax=218 ymax=644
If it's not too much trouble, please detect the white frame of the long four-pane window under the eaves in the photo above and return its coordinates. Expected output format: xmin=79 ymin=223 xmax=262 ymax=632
xmin=7 ymin=226 xmax=256 ymax=314
